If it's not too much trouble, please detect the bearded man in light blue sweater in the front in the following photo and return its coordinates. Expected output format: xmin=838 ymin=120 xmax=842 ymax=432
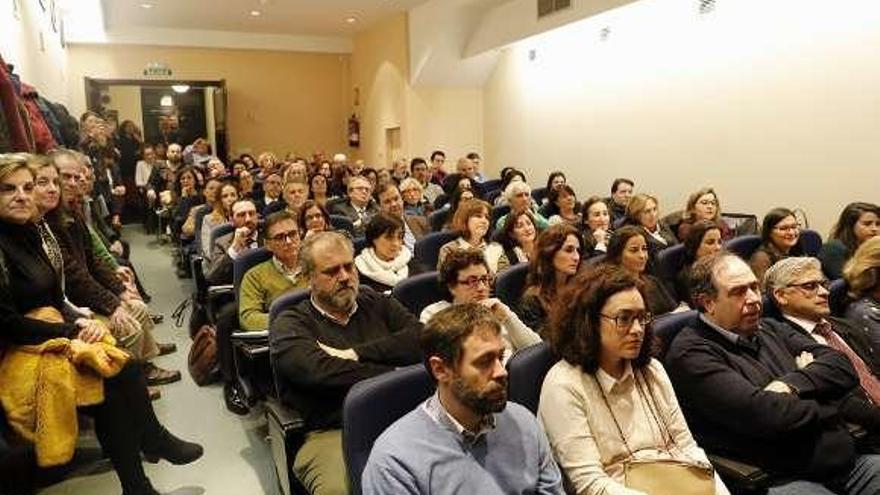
xmin=362 ymin=304 xmax=564 ymax=495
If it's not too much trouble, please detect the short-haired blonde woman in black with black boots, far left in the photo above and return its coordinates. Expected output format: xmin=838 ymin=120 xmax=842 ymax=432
xmin=0 ymin=154 xmax=202 ymax=495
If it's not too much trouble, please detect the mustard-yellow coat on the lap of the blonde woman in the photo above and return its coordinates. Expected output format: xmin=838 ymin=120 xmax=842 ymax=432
xmin=0 ymin=307 xmax=129 ymax=467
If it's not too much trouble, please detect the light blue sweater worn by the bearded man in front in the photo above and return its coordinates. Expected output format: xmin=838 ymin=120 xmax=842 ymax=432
xmin=362 ymin=399 xmax=564 ymax=495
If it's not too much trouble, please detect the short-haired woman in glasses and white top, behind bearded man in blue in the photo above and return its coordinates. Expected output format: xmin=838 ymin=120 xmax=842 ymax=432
xmin=419 ymin=249 xmax=541 ymax=362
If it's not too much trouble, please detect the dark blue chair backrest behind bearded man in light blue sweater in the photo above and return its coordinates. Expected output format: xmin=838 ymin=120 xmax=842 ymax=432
xmin=342 ymin=364 xmax=434 ymax=495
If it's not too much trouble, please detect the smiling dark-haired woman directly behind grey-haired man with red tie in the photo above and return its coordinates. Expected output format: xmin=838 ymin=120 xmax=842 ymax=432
xmin=749 ymin=208 xmax=802 ymax=280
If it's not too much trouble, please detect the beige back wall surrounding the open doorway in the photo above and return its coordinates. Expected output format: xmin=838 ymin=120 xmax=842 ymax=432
xmin=69 ymin=45 xmax=349 ymax=158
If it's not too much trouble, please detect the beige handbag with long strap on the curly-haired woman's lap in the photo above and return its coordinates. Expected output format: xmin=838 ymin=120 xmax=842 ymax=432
xmin=593 ymin=371 xmax=715 ymax=495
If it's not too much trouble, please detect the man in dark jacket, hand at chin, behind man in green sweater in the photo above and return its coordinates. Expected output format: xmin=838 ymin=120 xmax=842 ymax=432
xmin=205 ymin=199 xmax=261 ymax=285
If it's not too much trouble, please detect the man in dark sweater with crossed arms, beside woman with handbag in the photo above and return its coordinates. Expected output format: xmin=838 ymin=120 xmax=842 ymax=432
xmin=666 ymin=252 xmax=880 ymax=494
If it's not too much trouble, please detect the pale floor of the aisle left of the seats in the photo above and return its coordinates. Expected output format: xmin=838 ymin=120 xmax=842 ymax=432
xmin=40 ymin=227 xmax=280 ymax=495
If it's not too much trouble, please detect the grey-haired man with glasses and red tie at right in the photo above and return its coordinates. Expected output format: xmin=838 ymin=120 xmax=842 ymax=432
xmin=764 ymin=257 xmax=880 ymax=436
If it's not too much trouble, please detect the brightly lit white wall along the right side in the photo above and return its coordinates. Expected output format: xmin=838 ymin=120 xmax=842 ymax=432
xmin=483 ymin=0 xmax=880 ymax=235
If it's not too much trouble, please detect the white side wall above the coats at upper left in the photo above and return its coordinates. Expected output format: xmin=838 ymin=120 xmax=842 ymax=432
xmin=0 ymin=0 xmax=69 ymax=104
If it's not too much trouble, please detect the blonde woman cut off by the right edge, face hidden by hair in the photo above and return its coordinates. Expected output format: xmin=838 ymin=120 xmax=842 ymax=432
xmin=843 ymin=236 xmax=880 ymax=350
